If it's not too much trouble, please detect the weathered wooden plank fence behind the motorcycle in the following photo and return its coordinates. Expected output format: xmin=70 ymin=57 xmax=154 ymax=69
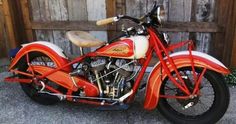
xmin=0 ymin=0 xmax=236 ymax=65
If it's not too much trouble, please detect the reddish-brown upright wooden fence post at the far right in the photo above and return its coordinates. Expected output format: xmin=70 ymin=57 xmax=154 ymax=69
xmin=210 ymin=0 xmax=235 ymax=66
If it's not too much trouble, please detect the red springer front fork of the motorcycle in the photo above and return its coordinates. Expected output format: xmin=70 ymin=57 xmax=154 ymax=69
xmin=149 ymin=31 xmax=206 ymax=98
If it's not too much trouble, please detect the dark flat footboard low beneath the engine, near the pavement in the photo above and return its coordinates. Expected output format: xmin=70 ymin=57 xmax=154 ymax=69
xmin=96 ymin=104 xmax=129 ymax=111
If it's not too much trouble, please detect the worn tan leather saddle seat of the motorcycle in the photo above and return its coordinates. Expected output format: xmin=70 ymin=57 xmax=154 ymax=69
xmin=66 ymin=31 xmax=106 ymax=47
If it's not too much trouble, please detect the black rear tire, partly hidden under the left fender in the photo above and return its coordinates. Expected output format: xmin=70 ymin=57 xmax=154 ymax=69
xmin=18 ymin=52 xmax=61 ymax=105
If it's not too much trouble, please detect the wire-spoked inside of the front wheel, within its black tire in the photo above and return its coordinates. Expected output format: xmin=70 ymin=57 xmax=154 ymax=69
xmin=160 ymin=70 xmax=218 ymax=116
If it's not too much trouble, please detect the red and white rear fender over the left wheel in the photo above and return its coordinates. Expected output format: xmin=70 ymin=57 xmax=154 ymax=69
xmin=9 ymin=41 xmax=71 ymax=72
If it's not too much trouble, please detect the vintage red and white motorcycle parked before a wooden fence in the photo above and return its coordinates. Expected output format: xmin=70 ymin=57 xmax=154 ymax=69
xmin=5 ymin=4 xmax=230 ymax=124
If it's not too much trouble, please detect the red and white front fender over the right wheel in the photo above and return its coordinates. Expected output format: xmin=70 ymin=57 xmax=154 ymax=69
xmin=144 ymin=51 xmax=230 ymax=110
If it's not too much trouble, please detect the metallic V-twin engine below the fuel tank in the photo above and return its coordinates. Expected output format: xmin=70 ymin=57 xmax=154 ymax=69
xmin=88 ymin=57 xmax=135 ymax=98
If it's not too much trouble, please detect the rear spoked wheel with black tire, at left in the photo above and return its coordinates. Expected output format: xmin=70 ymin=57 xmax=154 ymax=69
xmin=18 ymin=52 xmax=62 ymax=105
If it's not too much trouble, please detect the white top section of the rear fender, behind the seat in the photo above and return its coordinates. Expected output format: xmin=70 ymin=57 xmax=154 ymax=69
xmin=22 ymin=41 xmax=68 ymax=59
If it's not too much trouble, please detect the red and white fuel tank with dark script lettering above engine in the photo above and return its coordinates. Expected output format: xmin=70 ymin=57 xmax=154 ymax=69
xmin=96 ymin=36 xmax=149 ymax=59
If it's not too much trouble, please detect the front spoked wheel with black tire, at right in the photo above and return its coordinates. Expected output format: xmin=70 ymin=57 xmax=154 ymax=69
xmin=158 ymin=68 xmax=229 ymax=124
